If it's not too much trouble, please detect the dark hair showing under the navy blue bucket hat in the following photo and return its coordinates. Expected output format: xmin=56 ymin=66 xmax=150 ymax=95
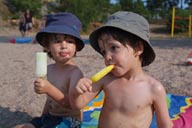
xmin=41 ymin=33 xmax=78 ymax=58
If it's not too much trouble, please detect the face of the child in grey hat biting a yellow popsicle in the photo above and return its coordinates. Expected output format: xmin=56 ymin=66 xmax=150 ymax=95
xmin=98 ymin=35 xmax=139 ymax=76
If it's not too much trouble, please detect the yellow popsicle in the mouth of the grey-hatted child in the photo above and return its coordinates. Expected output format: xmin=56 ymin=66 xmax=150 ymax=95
xmin=91 ymin=65 xmax=114 ymax=83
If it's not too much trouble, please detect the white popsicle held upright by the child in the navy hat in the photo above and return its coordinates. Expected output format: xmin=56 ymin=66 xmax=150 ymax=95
xmin=36 ymin=52 xmax=47 ymax=77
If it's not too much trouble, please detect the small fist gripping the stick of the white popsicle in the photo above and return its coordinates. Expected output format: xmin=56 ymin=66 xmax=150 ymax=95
xmin=34 ymin=78 xmax=50 ymax=94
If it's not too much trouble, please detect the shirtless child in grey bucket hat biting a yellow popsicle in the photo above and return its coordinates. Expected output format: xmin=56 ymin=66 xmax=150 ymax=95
xmin=70 ymin=11 xmax=171 ymax=128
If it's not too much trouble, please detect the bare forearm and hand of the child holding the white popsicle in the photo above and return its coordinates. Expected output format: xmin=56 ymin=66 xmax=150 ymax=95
xmin=34 ymin=78 xmax=64 ymax=105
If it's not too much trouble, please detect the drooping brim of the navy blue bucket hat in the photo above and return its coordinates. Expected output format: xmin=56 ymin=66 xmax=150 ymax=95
xmin=36 ymin=25 xmax=84 ymax=51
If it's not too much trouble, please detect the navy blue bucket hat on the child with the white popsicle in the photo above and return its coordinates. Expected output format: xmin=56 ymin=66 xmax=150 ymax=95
xmin=36 ymin=12 xmax=84 ymax=51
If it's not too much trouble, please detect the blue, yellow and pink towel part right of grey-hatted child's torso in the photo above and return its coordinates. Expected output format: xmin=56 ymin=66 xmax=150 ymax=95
xmin=150 ymin=94 xmax=192 ymax=128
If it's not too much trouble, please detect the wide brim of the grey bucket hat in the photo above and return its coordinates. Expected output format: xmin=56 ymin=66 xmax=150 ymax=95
xmin=89 ymin=24 xmax=155 ymax=66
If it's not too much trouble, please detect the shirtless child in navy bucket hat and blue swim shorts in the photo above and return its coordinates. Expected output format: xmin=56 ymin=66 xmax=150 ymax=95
xmin=16 ymin=13 xmax=84 ymax=128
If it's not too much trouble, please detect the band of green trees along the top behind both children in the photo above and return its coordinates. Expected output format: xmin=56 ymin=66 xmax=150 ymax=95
xmin=0 ymin=0 xmax=192 ymax=31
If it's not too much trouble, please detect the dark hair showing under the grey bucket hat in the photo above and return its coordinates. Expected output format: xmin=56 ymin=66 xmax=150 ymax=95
xmin=97 ymin=27 xmax=146 ymax=65
